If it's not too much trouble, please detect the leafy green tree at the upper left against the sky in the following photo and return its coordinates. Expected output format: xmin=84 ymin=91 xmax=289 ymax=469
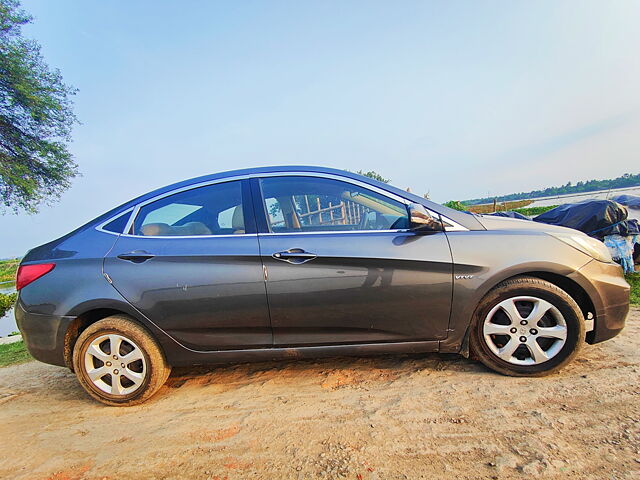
xmin=0 ymin=0 xmax=78 ymax=213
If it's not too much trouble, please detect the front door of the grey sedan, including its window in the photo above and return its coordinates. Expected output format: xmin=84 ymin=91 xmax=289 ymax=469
xmin=254 ymin=176 xmax=452 ymax=346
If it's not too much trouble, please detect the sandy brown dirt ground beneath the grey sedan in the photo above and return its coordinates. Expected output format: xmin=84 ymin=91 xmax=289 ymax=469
xmin=0 ymin=309 xmax=640 ymax=480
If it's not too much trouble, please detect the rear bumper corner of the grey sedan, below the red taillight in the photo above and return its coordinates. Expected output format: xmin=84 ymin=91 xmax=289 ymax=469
xmin=15 ymin=302 xmax=75 ymax=367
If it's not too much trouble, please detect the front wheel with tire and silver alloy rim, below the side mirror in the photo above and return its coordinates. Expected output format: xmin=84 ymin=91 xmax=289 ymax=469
xmin=469 ymin=276 xmax=585 ymax=377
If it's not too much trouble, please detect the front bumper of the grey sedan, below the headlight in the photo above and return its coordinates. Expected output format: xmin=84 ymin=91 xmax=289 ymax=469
xmin=574 ymin=260 xmax=631 ymax=343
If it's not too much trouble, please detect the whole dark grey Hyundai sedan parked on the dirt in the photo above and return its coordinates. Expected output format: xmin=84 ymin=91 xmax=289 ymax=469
xmin=16 ymin=167 xmax=629 ymax=405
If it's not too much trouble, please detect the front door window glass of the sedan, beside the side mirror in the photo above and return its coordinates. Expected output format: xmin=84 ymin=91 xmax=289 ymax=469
xmin=261 ymin=176 xmax=409 ymax=233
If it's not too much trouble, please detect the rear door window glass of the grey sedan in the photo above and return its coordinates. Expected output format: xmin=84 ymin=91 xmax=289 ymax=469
xmin=133 ymin=181 xmax=245 ymax=236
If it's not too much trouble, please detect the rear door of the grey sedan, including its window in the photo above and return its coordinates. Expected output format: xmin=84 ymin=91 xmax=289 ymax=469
xmin=104 ymin=180 xmax=272 ymax=350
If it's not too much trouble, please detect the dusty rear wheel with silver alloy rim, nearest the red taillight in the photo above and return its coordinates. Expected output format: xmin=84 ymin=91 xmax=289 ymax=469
xmin=73 ymin=315 xmax=171 ymax=406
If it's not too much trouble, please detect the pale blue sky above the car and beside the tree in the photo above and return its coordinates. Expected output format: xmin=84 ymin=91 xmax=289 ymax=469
xmin=0 ymin=0 xmax=640 ymax=257
